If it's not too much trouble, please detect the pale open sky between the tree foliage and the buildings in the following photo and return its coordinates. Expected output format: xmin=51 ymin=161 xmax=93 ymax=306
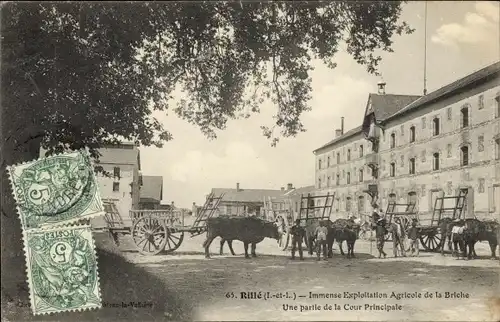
xmin=140 ymin=1 xmax=500 ymax=207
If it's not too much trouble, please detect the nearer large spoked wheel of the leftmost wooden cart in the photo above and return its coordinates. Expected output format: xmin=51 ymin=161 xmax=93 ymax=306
xmin=132 ymin=216 xmax=168 ymax=255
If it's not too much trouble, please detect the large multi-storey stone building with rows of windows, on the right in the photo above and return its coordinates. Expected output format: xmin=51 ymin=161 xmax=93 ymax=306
xmin=314 ymin=62 xmax=500 ymax=218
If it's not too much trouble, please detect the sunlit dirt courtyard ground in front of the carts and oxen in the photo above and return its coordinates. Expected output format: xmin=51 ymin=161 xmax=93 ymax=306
xmin=96 ymin=228 xmax=500 ymax=321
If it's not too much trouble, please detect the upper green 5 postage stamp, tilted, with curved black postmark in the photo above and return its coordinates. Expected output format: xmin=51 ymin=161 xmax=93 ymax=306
xmin=7 ymin=150 xmax=104 ymax=230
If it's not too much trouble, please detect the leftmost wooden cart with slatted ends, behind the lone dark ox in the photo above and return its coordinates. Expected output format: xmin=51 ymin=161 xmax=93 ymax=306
xmin=105 ymin=194 xmax=224 ymax=255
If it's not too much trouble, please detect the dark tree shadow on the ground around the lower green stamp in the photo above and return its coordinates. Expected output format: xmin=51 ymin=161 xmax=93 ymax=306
xmin=2 ymin=231 xmax=193 ymax=321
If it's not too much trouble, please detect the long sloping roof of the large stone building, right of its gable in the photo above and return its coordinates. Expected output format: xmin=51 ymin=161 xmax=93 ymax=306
xmin=387 ymin=61 xmax=500 ymax=120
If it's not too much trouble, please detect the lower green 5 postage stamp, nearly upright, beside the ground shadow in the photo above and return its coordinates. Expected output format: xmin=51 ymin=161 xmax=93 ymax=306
xmin=25 ymin=225 xmax=102 ymax=315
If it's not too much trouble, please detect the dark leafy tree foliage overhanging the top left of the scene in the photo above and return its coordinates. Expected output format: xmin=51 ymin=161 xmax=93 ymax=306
xmin=2 ymin=1 xmax=412 ymax=157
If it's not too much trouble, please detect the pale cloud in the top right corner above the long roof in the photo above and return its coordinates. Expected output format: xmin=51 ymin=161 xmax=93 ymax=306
xmin=431 ymin=2 xmax=499 ymax=48
